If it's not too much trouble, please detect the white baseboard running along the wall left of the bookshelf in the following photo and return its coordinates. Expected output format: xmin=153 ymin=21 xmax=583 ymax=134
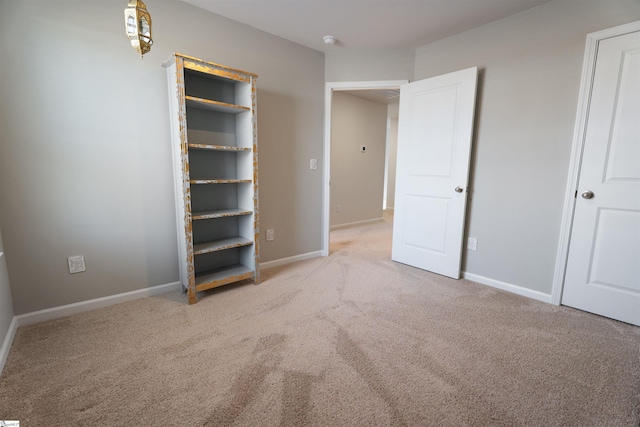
xmin=16 ymin=282 xmax=181 ymax=326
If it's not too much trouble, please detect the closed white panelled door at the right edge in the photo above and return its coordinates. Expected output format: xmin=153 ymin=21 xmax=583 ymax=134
xmin=562 ymin=31 xmax=640 ymax=326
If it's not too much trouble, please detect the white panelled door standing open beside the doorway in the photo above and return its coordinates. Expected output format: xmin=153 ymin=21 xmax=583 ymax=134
xmin=391 ymin=67 xmax=478 ymax=279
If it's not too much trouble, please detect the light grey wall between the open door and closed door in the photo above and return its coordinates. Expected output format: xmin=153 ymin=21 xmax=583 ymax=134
xmin=415 ymin=0 xmax=640 ymax=294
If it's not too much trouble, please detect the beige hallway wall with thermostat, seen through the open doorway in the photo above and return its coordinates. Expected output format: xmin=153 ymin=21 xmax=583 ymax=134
xmin=330 ymin=91 xmax=387 ymax=227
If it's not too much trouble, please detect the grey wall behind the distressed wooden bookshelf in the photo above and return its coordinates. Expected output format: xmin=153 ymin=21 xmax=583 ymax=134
xmin=0 ymin=0 xmax=324 ymax=314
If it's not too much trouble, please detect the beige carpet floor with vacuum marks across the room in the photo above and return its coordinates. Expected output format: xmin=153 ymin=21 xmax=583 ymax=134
xmin=0 ymin=216 xmax=640 ymax=427
